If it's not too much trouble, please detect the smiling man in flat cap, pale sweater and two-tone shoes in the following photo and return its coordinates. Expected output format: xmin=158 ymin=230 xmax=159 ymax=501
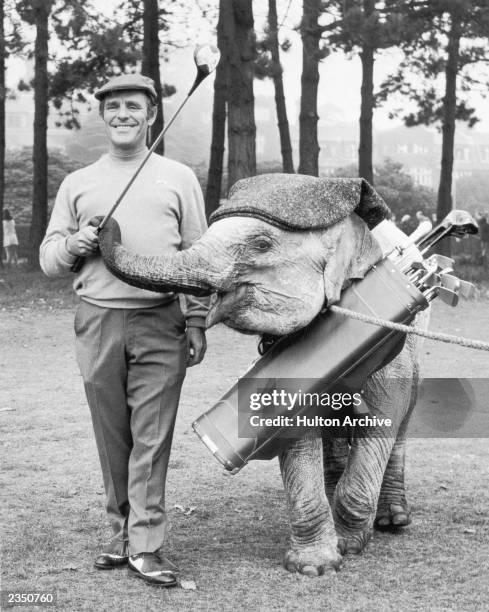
xmin=40 ymin=74 xmax=207 ymax=586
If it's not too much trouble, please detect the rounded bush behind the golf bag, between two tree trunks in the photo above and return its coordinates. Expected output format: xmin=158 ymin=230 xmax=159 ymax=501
xmin=334 ymin=158 xmax=436 ymax=221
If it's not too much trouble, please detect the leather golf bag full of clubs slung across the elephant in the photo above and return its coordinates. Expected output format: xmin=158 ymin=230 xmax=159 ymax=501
xmin=192 ymin=210 xmax=478 ymax=474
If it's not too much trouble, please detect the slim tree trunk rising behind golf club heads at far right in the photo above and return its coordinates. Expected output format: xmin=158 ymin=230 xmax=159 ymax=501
xmin=437 ymin=15 xmax=461 ymax=255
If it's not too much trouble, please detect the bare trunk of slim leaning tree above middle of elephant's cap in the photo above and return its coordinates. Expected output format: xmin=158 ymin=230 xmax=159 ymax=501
xmin=268 ymin=0 xmax=294 ymax=173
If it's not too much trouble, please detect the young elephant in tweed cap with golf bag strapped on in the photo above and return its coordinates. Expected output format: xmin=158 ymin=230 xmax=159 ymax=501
xmin=100 ymin=174 xmax=419 ymax=576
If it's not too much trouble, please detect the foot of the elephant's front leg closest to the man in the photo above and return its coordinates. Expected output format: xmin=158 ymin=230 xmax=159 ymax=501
xmin=284 ymin=544 xmax=341 ymax=578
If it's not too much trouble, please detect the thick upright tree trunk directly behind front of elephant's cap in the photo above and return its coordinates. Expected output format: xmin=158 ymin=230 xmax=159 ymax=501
xmin=223 ymin=0 xmax=256 ymax=188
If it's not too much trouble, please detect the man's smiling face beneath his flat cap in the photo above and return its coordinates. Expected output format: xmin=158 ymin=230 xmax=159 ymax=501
xmin=102 ymin=91 xmax=155 ymax=153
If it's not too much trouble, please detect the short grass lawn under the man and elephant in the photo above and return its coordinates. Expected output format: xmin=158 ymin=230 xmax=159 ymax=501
xmin=0 ymin=270 xmax=489 ymax=612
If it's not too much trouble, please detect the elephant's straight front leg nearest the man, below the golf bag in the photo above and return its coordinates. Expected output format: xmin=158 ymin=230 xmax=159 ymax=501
xmin=280 ymin=431 xmax=341 ymax=576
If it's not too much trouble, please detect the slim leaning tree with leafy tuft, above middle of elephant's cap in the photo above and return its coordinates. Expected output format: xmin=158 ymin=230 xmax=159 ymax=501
xmin=255 ymin=0 xmax=294 ymax=173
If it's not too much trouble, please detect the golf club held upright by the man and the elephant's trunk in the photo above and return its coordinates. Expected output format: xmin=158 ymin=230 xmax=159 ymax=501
xmin=71 ymin=44 xmax=221 ymax=272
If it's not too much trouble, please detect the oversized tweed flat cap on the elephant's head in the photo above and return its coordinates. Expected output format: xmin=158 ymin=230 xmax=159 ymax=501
xmin=210 ymin=173 xmax=391 ymax=230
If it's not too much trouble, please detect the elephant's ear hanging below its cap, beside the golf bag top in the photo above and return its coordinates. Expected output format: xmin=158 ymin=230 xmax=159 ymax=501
xmin=324 ymin=213 xmax=382 ymax=306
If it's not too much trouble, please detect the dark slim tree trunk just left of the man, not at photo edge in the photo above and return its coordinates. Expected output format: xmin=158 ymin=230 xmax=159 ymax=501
xmin=28 ymin=0 xmax=52 ymax=268
